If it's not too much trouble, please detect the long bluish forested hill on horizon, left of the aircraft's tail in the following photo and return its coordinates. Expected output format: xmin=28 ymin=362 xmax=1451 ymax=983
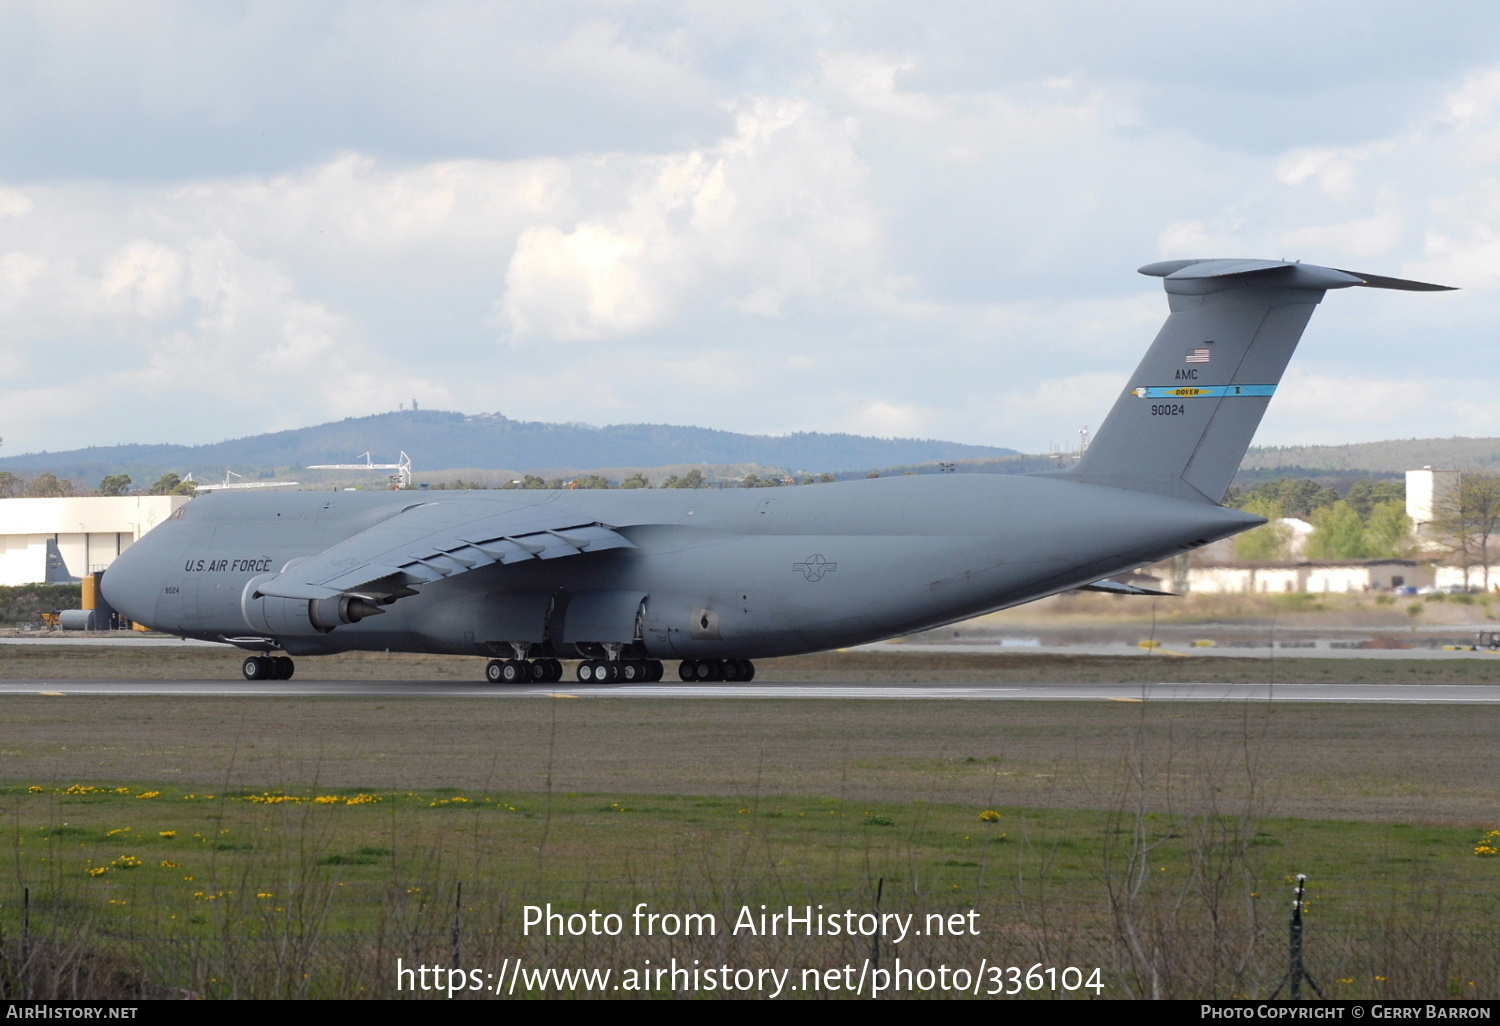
xmin=0 ymin=410 xmax=1016 ymax=483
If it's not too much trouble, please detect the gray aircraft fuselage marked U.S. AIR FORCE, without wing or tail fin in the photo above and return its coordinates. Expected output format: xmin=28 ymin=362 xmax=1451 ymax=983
xmin=104 ymin=474 xmax=1262 ymax=660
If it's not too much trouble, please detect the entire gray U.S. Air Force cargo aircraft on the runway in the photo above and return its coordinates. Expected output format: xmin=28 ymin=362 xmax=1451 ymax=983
xmin=104 ymin=260 xmax=1443 ymax=683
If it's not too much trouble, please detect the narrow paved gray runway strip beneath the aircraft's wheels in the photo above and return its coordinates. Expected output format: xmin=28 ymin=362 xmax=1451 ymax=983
xmin=0 ymin=680 xmax=1500 ymax=705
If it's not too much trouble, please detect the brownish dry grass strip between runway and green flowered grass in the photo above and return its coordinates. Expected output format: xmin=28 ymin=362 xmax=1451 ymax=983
xmin=0 ymin=695 xmax=1500 ymax=825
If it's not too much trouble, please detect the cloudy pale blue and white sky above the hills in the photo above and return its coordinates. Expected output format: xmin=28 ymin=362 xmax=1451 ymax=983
xmin=0 ymin=0 xmax=1500 ymax=456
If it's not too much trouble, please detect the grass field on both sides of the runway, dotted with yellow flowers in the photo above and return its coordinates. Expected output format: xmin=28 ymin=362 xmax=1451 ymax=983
xmin=0 ymin=647 xmax=1500 ymax=998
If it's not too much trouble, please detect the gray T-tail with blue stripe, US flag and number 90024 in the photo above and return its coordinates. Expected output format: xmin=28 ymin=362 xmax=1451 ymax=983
xmin=1071 ymin=260 xmax=1449 ymax=504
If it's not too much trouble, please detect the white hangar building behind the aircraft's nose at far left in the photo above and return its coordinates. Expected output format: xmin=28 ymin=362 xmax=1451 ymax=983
xmin=0 ymin=495 xmax=188 ymax=585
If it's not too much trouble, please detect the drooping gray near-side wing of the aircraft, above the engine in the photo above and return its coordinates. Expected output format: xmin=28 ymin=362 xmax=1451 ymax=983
xmin=255 ymin=500 xmax=635 ymax=602
